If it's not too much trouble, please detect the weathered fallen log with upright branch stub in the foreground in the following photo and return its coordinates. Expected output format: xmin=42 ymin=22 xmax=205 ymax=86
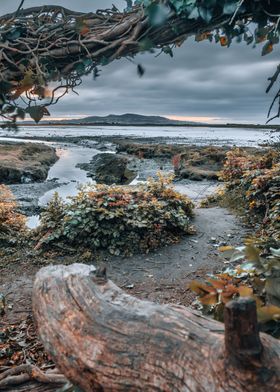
xmin=33 ymin=264 xmax=280 ymax=392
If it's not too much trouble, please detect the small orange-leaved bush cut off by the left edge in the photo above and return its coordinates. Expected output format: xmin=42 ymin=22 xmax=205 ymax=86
xmin=0 ymin=185 xmax=26 ymax=243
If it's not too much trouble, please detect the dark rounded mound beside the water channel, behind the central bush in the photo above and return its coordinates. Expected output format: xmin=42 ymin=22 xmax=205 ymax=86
xmin=77 ymin=153 xmax=136 ymax=185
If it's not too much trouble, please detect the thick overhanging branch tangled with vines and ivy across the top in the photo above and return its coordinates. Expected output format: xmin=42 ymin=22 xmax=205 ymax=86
xmin=0 ymin=2 xmax=278 ymax=122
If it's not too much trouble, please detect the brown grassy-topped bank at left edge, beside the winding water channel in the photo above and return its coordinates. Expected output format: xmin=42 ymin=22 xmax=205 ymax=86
xmin=0 ymin=142 xmax=58 ymax=184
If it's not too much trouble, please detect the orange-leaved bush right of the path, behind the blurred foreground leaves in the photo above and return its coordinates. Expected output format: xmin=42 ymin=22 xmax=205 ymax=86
xmin=222 ymin=149 xmax=280 ymax=242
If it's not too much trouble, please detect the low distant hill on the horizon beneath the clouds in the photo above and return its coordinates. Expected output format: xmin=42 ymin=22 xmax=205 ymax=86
xmin=62 ymin=113 xmax=197 ymax=125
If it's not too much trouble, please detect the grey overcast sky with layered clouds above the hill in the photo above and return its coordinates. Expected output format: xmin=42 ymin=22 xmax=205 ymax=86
xmin=0 ymin=0 xmax=280 ymax=123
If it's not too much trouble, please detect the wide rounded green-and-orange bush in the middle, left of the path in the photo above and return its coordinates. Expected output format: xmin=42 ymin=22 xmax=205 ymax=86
xmin=37 ymin=174 xmax=193 ymax=255
